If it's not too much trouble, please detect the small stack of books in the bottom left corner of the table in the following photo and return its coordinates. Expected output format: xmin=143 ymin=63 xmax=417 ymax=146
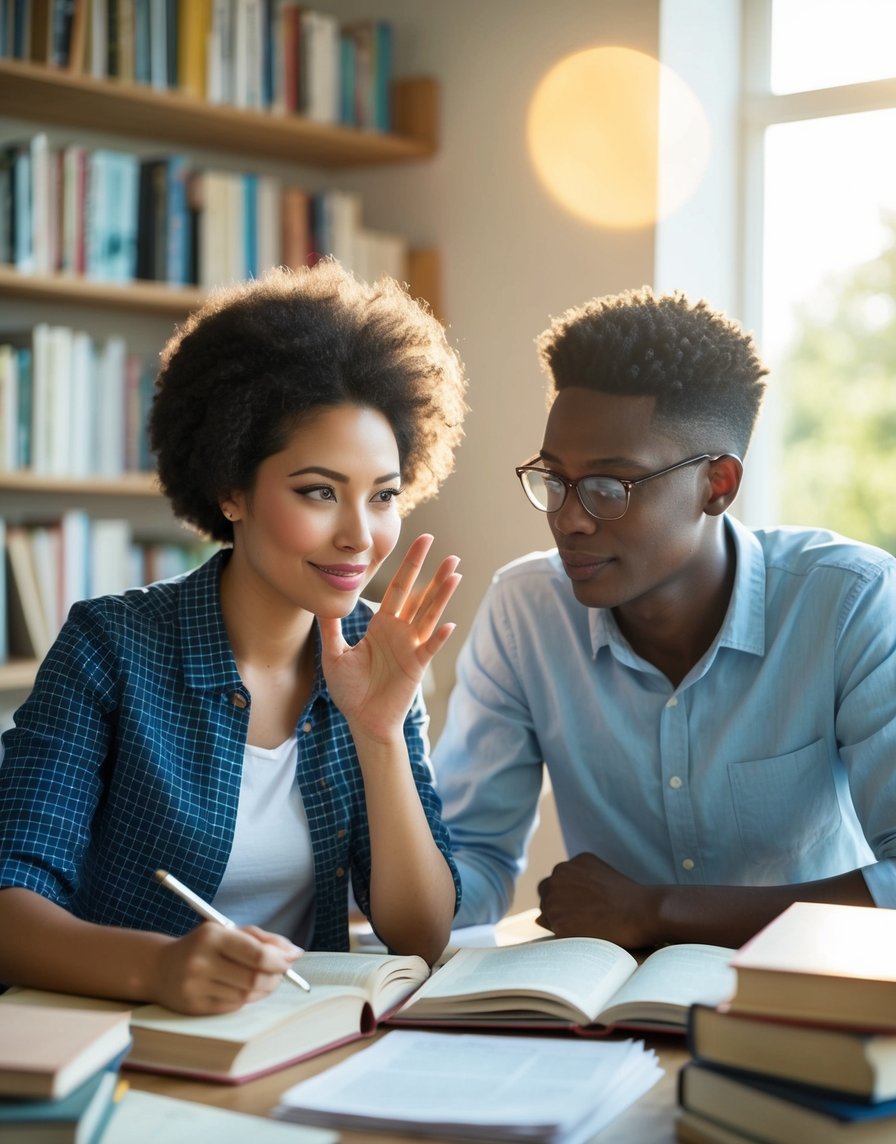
xmin=0 ymin=1004 xmax=130 ymax=1144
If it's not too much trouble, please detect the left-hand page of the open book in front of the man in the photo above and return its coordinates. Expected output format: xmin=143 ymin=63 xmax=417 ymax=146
xmin=399 ymin=937 xmax=637 ymax=1024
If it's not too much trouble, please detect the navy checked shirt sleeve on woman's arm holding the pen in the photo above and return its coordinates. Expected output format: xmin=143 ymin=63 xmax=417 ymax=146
xmin=0 ymin=605 xmax=117 ymax=907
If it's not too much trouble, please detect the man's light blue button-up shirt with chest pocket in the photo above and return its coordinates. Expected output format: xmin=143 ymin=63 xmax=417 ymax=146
xmin=433 ymin=518 xmax=896 ymax=924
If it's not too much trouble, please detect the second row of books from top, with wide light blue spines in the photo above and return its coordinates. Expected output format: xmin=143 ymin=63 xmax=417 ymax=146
xmin=0 ymin=132 xmax=407 ymax=289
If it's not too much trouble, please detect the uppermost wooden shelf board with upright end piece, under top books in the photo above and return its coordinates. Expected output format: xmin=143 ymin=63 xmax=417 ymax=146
xmin=0 ymin=59 xmax=438 ymax=168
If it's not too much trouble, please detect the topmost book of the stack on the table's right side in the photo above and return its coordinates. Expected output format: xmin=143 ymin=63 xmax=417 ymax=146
xmin=730 ymin=901 xmax=896 ymax=1032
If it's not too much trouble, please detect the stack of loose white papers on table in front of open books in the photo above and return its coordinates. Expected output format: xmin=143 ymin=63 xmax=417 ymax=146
xmin=273 ymin=1031 xmax=663 ymax=1144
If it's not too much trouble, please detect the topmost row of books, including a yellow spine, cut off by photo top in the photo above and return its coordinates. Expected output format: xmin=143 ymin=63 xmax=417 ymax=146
xmin=0 ymin=0 xmax=393 ymax=132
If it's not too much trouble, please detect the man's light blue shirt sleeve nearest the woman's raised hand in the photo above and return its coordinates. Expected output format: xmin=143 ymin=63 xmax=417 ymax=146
xmin=433 ymin=582 xmax=542 ymax=925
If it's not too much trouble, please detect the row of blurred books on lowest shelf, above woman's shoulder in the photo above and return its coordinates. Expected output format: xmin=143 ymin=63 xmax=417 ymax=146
xmin=0 ymin=509 xmax=214 ymax=664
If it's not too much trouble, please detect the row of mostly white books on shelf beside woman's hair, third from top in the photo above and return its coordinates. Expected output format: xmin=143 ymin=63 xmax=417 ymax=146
xmin=0 ymin=321 xmax=156 ymax=479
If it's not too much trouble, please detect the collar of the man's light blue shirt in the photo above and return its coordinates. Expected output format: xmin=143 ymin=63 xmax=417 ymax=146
xmin=588 ymin=516 xmax=766 ymax=657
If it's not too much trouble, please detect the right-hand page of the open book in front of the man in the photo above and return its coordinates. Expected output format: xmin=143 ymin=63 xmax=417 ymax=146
xmin=600 ymin=944 xmax=735 ymax=1025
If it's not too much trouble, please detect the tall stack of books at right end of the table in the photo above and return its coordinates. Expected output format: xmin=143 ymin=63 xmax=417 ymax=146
xmin=676 ymin=901 xmax=896 ymax=1144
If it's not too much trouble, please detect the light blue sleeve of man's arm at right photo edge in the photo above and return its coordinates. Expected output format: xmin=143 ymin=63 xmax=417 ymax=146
xmin=836 ymin=561 xmax=896 ymax=907
